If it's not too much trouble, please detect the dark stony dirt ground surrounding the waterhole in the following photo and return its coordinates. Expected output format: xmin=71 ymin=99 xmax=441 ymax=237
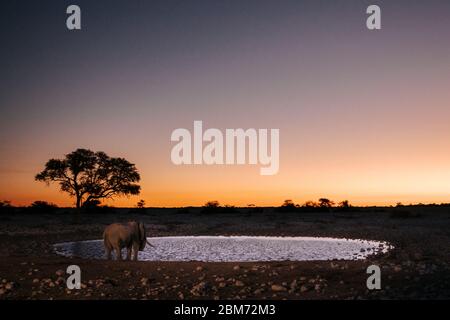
xmin=0 ymin=207 xmax=450 ymax=299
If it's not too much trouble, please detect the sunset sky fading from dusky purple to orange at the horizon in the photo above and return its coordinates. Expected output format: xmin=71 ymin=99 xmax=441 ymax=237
xmin=0 ymin=0 xmax=450 ymax=206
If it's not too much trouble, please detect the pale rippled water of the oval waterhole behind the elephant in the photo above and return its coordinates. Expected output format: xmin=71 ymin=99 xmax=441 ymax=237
xmin=54 ymin=236 xmax=391 ymax=262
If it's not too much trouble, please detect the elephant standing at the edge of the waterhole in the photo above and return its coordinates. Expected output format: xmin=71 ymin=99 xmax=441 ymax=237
xmin=103 ymin=221 xmax=153 ymax=261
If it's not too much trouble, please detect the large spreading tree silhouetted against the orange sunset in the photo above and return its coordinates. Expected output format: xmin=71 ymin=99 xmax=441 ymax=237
xmin=35 ymin=149 xmax=141 ymax=209
